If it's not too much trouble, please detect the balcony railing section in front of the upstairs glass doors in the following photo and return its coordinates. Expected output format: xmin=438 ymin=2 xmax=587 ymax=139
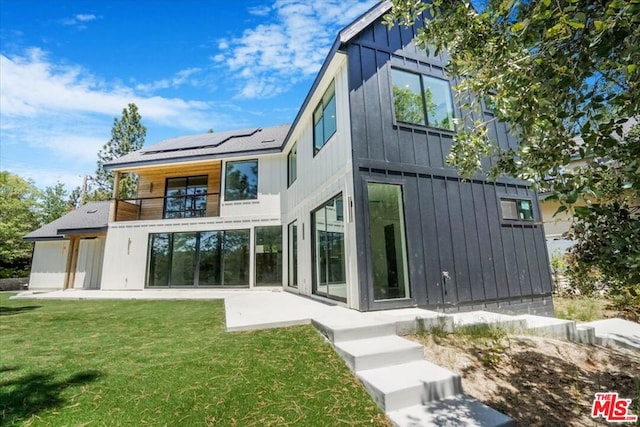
xmin=114 ymin=192 xmax=220 ymax=221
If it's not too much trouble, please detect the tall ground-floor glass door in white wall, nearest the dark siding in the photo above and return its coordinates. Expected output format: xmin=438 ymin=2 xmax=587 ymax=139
xmin=311 ymin=194 xmax=347 ymax=301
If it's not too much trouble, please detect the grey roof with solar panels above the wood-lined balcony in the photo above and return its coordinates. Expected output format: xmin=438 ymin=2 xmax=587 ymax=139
xmin=105 ymin=125 xmax=289 ymax=169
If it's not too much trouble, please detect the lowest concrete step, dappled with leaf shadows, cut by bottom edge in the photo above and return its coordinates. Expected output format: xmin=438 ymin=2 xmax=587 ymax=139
xmin=387 ymin=395 xmax=516 ymax=427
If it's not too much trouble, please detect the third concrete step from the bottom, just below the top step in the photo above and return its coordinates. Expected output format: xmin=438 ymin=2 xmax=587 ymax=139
xmin=334 ymin=335 xmax=424 ymax=372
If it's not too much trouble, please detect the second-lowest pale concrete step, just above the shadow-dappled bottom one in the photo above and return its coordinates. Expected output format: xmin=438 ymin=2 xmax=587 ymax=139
xmin=356 ymin=360 xmax=462 ymax=412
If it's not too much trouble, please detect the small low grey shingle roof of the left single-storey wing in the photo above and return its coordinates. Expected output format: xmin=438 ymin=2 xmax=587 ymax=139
xmin=23 ymin=201 xmax=110 ymax=242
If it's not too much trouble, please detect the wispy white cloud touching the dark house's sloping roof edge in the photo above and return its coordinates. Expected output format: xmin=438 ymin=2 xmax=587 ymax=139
xmin=212 ymin=0 xmax=376 ymax=98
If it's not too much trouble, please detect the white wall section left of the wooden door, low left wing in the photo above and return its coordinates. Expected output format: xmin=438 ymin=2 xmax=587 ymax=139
xmin=29 ymin=240 xmax=69 ymax=290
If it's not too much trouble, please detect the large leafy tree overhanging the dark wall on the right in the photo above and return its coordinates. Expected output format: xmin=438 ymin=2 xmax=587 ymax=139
xmin=385 ymin=0 xmax=640 ymax=286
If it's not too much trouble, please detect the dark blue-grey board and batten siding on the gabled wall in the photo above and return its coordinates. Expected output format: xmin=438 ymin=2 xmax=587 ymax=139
xmin=345 ymin=15 xmax=551 ymax=311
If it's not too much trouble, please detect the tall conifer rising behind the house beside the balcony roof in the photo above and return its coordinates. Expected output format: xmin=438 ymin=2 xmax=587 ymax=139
xmin=94 ymin=103 xmax=147 ymax=200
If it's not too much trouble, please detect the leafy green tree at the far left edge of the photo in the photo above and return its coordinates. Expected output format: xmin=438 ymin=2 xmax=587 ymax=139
xmin=0 ymin=171 xmax=40 ymax=277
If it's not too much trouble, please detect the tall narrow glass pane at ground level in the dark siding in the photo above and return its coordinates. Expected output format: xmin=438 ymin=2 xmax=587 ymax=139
xmin=367 ymin=182 xmax=410 ymax=300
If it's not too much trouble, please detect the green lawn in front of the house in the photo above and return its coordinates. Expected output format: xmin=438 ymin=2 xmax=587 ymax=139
xmin=0 ymin=293 xmax=389 ymax=426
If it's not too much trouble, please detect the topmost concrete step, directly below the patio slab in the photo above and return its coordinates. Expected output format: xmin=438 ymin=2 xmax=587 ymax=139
xmin=311 ymin=319 xmax=396 ymax=344
